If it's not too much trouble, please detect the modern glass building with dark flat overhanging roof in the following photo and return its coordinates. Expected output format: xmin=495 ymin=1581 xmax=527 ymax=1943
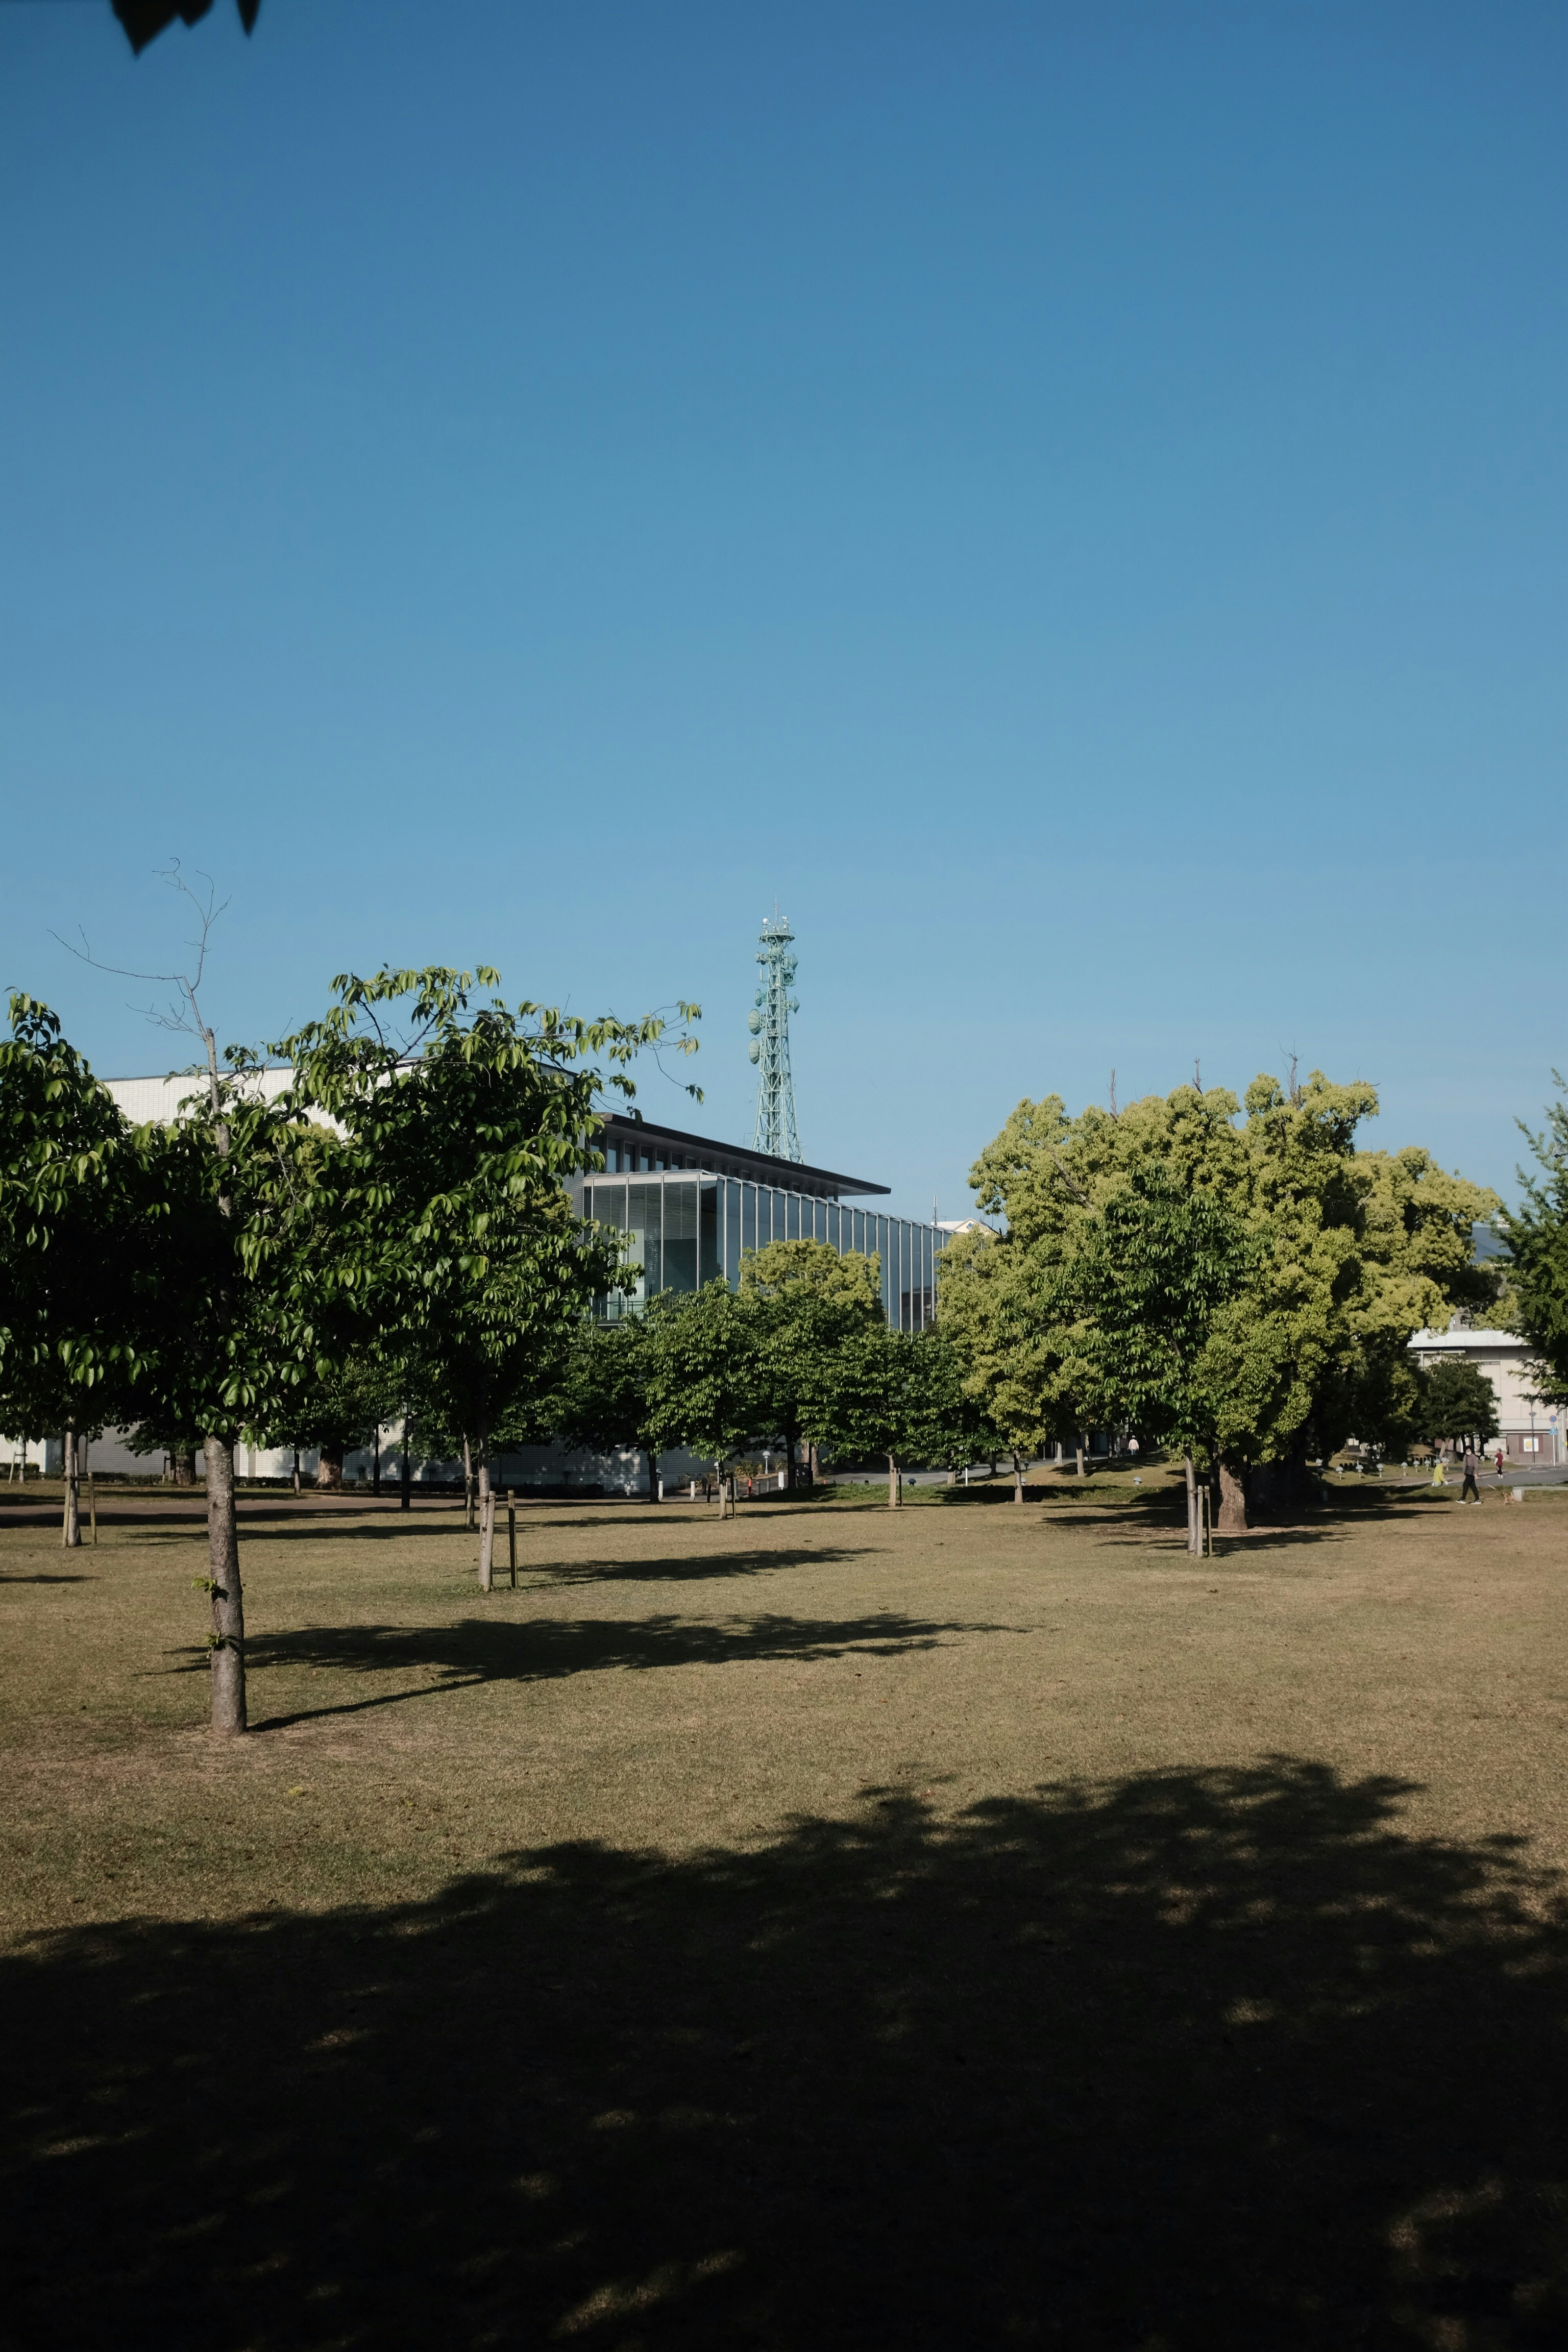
xmin=571 ymin=1117 xmax=947 ymax=1331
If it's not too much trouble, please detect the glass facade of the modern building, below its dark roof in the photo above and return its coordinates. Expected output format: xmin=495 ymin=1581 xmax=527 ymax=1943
xmin=571 ymin=1171 xmax=947 ymax=1331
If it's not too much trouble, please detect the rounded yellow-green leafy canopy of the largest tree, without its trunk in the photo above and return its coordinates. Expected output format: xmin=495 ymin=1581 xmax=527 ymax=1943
xmin=940 ymin=1070 xmax=1498 ymax=1467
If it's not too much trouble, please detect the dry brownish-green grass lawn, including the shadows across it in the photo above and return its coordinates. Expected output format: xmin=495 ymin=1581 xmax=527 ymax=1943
xmin=0 ymin=1477 xmax=1568 ymax=2352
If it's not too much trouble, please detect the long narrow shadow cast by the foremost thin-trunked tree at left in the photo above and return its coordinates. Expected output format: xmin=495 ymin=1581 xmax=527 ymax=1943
xmin=211 ymin=1609 xmax=1018 ymax=1731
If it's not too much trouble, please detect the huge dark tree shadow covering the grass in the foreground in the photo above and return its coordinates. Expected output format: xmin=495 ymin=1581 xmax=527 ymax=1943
xmin=0 ymin=1759 xmax=1568 ymax=2352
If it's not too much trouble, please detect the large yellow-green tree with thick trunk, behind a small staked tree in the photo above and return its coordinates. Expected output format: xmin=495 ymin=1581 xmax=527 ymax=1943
xmin=971 ymin=1070 xmax=1498 ymax=1529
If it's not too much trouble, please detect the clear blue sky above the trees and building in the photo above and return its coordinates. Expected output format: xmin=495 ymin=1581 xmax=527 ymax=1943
xmin=0 ymin=0 xmax=1568 ymax=1216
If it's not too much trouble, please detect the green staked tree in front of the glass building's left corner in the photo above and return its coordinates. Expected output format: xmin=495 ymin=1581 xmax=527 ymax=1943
xmin=275 ymin=967 xmax=696 ymax=1592
